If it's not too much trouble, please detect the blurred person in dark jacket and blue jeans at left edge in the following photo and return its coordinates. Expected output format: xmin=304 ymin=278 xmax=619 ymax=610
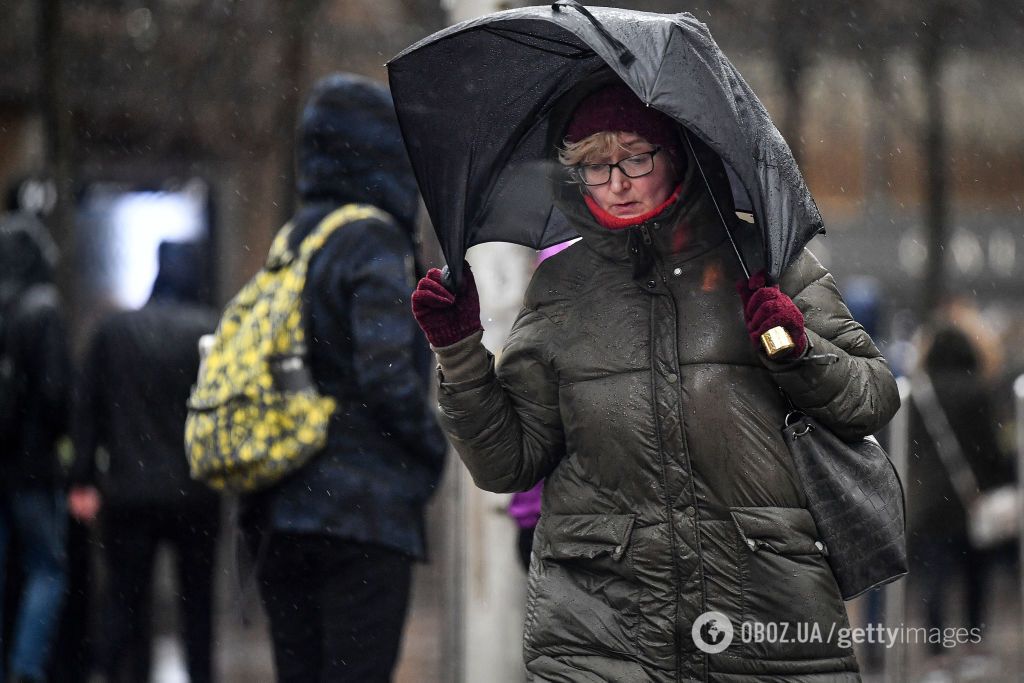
xmin=0 ymin=214 xmax=71 ymax=682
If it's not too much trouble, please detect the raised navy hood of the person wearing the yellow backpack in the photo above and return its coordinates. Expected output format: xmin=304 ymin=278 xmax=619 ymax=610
xmin=296 ymin=74 xmax=419 ymax=230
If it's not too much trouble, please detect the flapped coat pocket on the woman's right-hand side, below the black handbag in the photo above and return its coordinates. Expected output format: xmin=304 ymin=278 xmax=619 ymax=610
xmin=731 ymin=507 xmax=849 ymax=659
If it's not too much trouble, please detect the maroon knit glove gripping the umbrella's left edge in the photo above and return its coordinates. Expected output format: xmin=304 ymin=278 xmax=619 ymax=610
xmin=413 ymin=263 xmax=483 ymax=348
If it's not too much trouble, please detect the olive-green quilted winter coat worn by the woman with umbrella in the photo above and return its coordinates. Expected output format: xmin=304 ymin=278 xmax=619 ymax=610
xmin=438 ymin=131 xmax=899 ymax=683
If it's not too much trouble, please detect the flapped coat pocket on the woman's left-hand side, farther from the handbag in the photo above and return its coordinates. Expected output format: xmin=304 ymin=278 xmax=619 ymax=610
xmin=524 ymin=514 xmax=639 ymax=654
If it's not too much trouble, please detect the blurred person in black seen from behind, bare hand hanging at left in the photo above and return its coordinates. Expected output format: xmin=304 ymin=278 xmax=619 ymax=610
xmin=69 ymin=243 xmax=219 ymax=683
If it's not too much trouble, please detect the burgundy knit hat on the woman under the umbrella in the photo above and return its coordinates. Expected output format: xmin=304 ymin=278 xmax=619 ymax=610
xmin=565 ymin=83 xmax=679 ymax=150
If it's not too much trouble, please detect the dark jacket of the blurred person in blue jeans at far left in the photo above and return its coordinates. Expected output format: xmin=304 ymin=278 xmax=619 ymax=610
xmin=0 ymin=214 xmax=71 ymax=490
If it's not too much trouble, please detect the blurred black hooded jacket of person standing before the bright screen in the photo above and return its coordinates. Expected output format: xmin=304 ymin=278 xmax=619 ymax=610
xmin=71 ymin=243 xmax=217 ymax=511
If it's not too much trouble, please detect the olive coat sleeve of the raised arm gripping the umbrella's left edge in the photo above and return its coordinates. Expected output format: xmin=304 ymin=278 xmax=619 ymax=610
xmin=435 ymin=308 xmax=565 ymax=493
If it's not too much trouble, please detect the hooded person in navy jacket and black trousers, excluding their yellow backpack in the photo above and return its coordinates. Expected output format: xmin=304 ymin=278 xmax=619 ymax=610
xmin=243 ymin=74 xmax=446 ymax=683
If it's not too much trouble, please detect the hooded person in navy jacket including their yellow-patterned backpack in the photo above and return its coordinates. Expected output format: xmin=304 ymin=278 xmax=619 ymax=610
xmin=211 ymin=74 xmax=446 ymax=683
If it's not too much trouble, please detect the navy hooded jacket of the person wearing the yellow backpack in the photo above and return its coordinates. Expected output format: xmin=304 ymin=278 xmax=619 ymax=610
xmin=246 ymin=75 xmax=446 ymax=556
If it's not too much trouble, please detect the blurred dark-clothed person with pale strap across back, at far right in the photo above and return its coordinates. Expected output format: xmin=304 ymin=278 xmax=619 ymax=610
xmin=906 ymin=324 xmax=1013 ymax=653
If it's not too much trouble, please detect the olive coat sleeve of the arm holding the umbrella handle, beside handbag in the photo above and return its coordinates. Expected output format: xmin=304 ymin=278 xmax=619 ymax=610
xmin=764 ymin=250 xmax=900 ymax=440
